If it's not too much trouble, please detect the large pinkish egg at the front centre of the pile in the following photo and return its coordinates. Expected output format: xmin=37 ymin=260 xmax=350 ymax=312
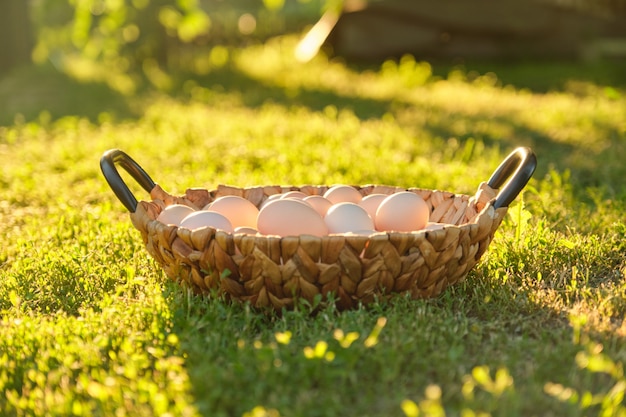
xmin=257 ymin=199 xmax=328 ymax=237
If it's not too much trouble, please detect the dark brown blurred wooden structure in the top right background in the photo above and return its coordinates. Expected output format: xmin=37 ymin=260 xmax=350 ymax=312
xmin=306 ymin=0 xmax=626 ymax=61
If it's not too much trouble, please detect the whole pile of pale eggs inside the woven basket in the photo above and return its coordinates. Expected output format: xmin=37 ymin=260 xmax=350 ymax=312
xmin=157 ymin=185 xmax=441 ymax=237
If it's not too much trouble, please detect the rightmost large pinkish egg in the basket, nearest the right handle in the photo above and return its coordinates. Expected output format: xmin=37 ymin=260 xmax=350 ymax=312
xmin=375 ymin=191 xmax=430 ymax=232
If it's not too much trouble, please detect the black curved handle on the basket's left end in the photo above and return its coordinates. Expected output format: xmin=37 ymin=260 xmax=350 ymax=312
xmin=100 ymin=149 xmax=156 ymax=213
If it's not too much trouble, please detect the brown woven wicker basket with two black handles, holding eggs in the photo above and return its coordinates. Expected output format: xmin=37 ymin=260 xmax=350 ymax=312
xmin=100 ymin=148 xmax=536 ymax=310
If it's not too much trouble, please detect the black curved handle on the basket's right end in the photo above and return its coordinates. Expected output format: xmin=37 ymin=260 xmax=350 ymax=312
xmin=487 ymin=147 xmax=537 ymax=208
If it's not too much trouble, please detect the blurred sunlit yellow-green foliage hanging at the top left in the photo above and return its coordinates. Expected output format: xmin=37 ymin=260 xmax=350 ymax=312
xmin=31 ymin=0 xmax=332 ymax=94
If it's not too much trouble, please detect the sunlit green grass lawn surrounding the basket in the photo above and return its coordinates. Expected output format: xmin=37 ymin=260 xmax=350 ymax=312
xmin=0 ymin=37 xmax=626 ymax=417
